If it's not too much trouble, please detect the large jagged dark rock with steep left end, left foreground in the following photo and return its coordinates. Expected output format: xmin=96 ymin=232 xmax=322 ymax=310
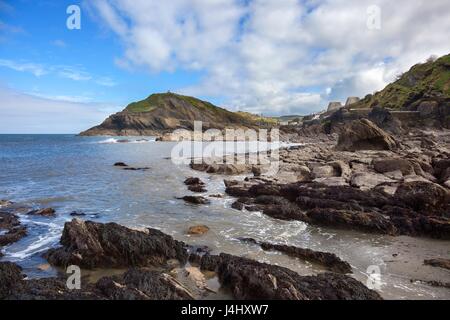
xmin=45 ymin=219 xmax=188 ymax=269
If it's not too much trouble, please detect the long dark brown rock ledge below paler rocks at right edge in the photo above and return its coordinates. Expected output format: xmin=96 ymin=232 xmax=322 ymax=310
xmin=226 ymin=182 xmax=450 ymax=239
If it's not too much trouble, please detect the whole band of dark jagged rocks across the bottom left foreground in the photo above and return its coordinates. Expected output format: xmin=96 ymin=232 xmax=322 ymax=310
xmin=0 ymin=219 xmax=381 ymax=300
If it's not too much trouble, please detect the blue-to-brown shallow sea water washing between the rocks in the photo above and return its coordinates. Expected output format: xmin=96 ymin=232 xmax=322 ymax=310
xmin=0 ymin=135 xmax=450 ymax=299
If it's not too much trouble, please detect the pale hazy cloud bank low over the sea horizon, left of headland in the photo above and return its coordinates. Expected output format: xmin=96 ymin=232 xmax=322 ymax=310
xmin=0 ymin=86 xmax=117 ymax=133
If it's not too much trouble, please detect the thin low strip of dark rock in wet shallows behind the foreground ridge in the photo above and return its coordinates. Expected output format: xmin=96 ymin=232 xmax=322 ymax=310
xmin=241 ymin=238 xmax=352 ymax=274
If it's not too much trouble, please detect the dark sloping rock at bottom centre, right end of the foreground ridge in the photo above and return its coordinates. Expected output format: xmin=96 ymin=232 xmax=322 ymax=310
xmin=197 ymin=253 xmax=381 ymax=300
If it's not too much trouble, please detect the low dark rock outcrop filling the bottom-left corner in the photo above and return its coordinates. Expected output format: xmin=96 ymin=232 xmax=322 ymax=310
xmin=0 ymin=262 xmax=194 ymax=300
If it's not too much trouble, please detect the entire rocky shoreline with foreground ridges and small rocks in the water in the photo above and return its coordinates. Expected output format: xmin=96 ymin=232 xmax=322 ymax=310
xmin=0 ymin=120 xmax=450 ymax=300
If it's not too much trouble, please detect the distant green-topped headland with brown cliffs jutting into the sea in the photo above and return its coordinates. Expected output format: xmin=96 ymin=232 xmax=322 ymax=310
xmin=80 ymin=93 xmax=257 ymax=136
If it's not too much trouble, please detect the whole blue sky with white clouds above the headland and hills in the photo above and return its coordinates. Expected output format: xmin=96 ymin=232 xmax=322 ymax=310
xmin=0 ymin=0 xmax=450 ymax=133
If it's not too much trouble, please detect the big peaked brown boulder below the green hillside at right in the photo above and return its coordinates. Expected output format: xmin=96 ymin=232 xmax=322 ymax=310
xmin=336 ymin=119 xmax=397 ymax=151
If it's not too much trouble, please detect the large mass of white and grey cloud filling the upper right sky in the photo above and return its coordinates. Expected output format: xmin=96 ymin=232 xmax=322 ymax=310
xmin=90 ymin=0 xmax=450 ymax=114
